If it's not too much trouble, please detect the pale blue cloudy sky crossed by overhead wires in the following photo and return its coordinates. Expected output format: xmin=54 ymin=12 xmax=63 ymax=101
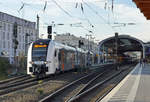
xmin=0 ymin=0 xmax=150 ymax=42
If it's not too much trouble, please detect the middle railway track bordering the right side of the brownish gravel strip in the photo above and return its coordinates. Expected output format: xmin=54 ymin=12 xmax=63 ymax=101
xmin=40 ymin=67 xmax=112 ymax=102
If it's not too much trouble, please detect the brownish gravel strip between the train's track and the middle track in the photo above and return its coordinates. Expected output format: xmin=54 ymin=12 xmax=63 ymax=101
xmin=0 ymin=71 xmax=91 ymax=102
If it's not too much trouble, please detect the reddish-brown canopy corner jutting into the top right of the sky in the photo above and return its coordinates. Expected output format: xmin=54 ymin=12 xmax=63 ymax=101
xmin=133 ymin=0 xmax=150 ymax=20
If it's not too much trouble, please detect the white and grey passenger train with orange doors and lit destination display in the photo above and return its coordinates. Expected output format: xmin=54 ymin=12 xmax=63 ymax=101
xmin=27 ymin=39 xmax=91 ymax=77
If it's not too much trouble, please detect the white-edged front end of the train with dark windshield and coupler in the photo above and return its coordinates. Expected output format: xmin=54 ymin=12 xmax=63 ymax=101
xmin=27 ymin=39 xmax=50 ymax=77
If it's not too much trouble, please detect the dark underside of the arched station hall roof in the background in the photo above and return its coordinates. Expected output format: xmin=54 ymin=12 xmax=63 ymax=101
xmin=99 ymin=35 xmax=144 ymax=54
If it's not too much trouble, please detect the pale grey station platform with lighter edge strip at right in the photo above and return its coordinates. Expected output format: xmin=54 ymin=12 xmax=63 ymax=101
xmin=100 ymin=64 xmax=150 ymax=102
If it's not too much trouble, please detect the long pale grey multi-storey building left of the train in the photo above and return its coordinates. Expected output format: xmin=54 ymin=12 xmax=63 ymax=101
xmin=0 ymin=12 xmax=39 ymax=63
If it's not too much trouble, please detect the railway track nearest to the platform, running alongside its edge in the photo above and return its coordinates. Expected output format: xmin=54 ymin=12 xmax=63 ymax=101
xmin=66 ymin=66 xmax=135 ymax=102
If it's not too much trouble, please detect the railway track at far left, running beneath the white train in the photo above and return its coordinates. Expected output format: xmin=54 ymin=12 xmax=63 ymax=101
xmin=0 ymin=68 xmax=93 ymax=96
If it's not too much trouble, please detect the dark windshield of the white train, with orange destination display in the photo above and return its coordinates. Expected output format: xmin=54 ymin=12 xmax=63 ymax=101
xmin=32 ymin=40 xmax=49 ymax=61
